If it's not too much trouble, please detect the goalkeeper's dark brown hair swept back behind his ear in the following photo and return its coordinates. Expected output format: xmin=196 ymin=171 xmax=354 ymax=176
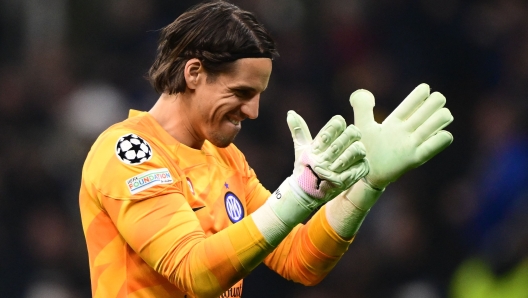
xmin=148 ymin=1 xmax=278 ymax=94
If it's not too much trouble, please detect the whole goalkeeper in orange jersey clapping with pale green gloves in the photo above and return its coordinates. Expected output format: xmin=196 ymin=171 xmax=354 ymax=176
xmin=79 ymin=1 xmax=452 ymax=297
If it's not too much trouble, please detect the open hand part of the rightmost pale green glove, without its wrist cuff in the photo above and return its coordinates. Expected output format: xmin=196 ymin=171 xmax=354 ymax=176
xmin=350 ymin=84 xmax=453 ymax=189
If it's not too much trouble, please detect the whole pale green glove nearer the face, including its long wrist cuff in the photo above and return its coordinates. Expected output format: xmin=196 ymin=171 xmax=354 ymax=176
xmin=252 ymin=111 xmax=369 ymax=245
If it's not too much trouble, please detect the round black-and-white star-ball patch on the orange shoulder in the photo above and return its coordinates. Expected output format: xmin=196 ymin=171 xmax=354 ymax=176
xmin=116 ymin=133 xmax=152 ymax=166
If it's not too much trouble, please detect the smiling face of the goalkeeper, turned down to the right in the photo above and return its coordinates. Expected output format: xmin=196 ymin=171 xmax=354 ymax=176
xmin=187 ymin=58 xmax=271 ymax=148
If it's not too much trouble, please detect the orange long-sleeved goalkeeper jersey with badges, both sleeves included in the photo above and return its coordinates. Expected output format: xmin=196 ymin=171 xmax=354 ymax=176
xmin=79 ymin=111 xmax=351 ymax=298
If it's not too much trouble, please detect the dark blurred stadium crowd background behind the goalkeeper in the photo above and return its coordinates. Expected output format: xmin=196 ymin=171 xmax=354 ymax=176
xmin=0 ymin=0 xmax=528 ymax=298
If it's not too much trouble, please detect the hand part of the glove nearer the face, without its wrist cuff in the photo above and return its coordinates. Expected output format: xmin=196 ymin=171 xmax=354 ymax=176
xmin=287 ymin=111 xmax=369 ymax=198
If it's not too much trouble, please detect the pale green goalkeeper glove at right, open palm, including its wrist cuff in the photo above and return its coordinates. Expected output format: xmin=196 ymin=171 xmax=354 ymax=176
xmin=326 ymin=84 xmax=453 ymax=237
